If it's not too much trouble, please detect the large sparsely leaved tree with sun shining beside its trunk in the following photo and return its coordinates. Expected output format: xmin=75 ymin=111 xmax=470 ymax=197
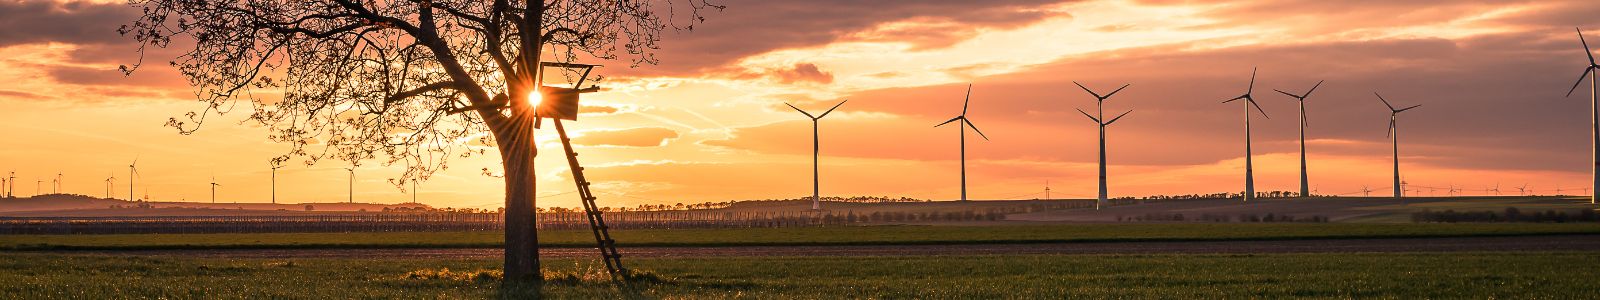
xmin=118 ymin=0 xmax=722 ymax=281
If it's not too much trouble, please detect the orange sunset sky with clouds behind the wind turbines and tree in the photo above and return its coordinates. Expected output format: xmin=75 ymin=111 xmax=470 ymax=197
xmin=0 ymin=0 xmax=1600 ymax=209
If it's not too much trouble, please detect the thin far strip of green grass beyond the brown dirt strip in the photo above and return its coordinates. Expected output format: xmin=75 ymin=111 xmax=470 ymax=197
xmin=0 ymin=223 xmax=1600 ymax=251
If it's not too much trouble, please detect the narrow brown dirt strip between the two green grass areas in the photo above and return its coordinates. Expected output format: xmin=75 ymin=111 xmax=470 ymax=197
xmin=53 ymin=235 xmax=1600 ymax=259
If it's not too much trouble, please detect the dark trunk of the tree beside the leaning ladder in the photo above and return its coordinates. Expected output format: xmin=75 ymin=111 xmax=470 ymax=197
xmin=490 ymin=113 xmax=544 ymax=282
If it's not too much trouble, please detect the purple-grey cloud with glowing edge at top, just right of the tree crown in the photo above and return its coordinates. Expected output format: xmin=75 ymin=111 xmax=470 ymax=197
xmin=614 ymin=0 xmax=1070 ymax=77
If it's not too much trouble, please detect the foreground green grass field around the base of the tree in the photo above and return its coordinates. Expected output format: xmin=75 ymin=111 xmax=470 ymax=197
xmin=0 ymin=252 xmax=1600 ymax=298
